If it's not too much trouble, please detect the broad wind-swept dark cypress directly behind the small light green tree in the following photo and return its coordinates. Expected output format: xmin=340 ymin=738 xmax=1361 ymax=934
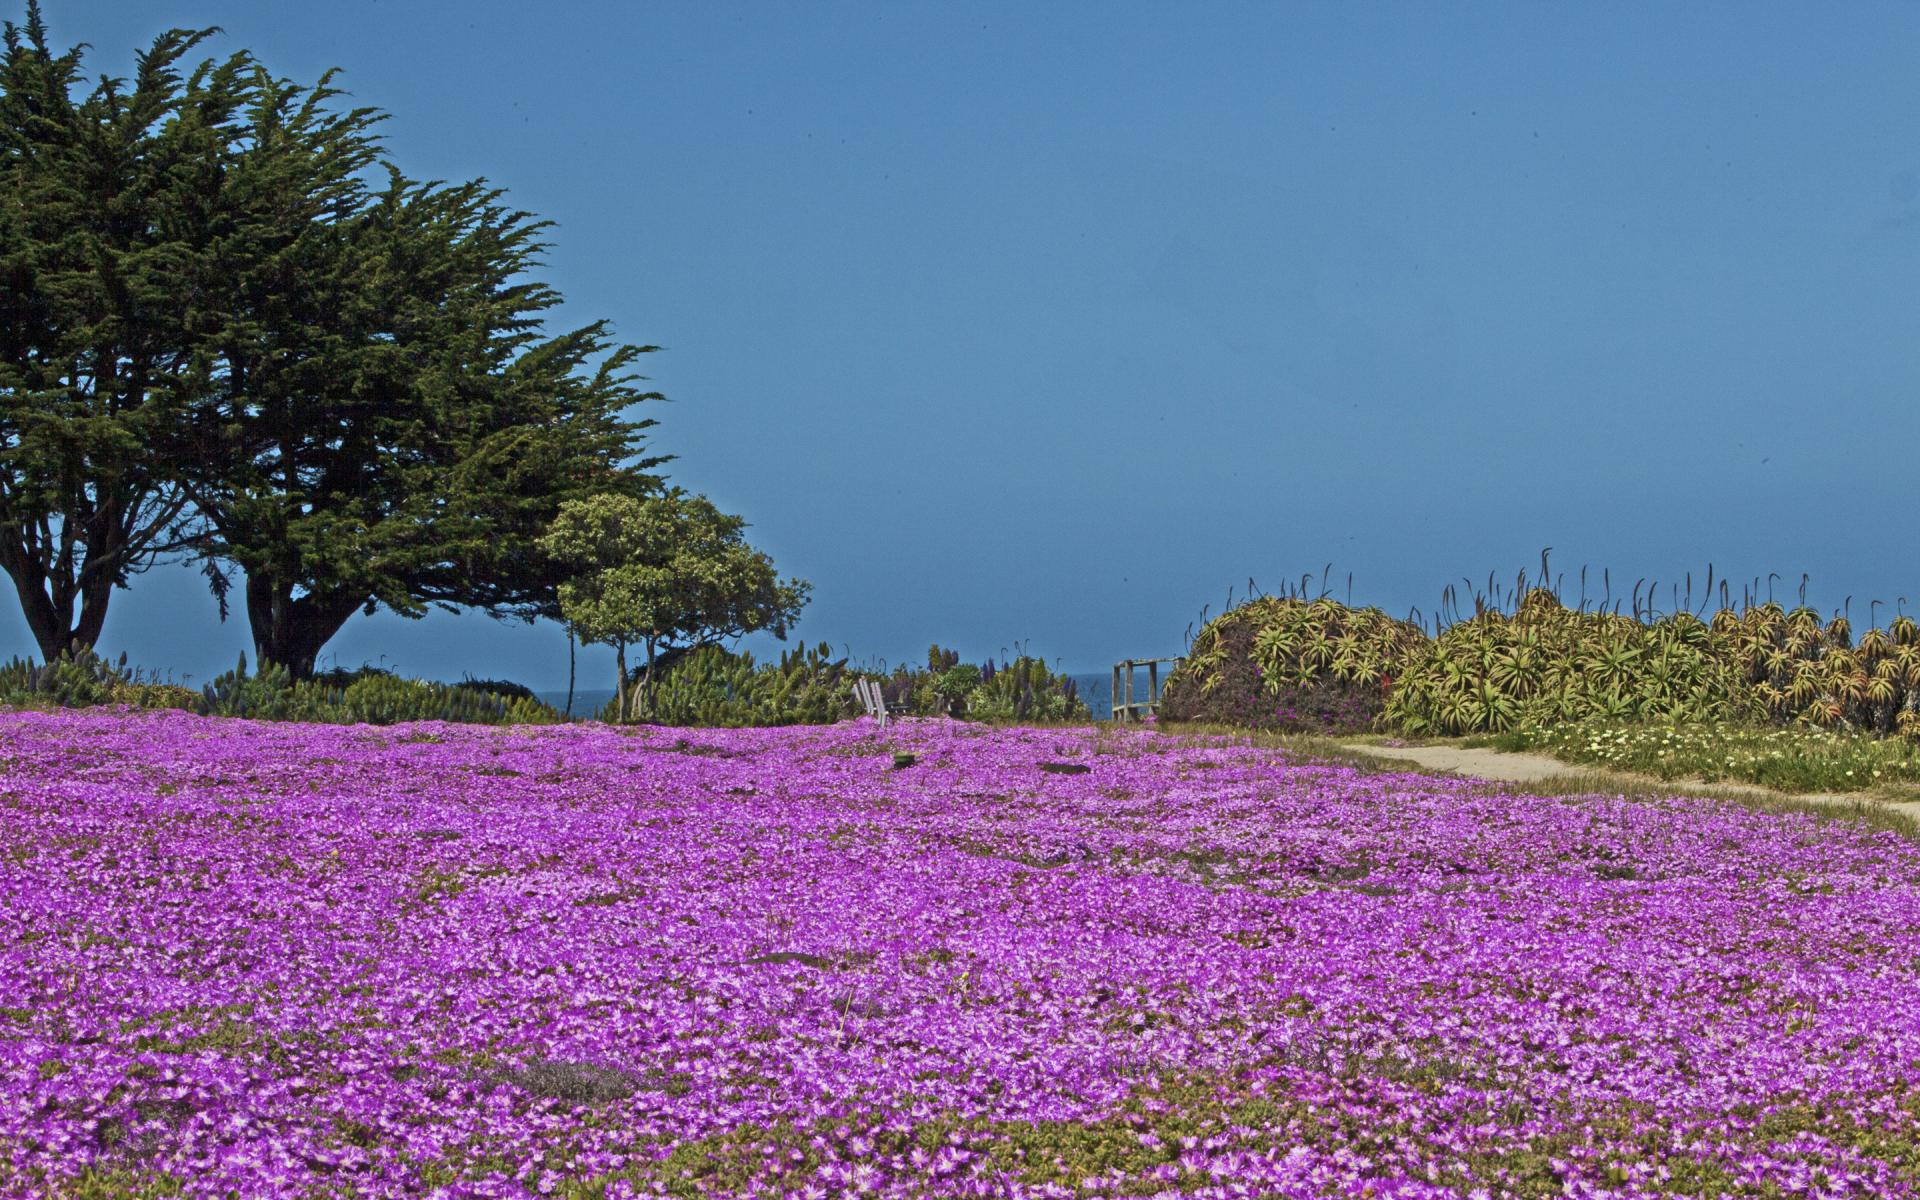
xmin=179 ymin=70 xmax=660 ymax=674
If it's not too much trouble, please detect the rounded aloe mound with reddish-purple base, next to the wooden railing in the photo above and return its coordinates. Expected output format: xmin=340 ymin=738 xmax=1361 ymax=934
xmin=1160 ymin=597 xmax=1430 ymax=733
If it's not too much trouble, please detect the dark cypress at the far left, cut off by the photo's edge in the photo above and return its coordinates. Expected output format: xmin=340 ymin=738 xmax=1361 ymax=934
xmin=0 ymin=4 xmax=217 ymax=660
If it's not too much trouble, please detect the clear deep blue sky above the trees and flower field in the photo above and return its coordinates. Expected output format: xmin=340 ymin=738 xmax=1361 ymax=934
xmin=0 ymin=0 xmax=1920 ymax=685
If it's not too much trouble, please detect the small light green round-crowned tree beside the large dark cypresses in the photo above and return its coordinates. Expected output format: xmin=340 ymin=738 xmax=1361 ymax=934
xmin=540 ymin=488 xmax=808 ymax=720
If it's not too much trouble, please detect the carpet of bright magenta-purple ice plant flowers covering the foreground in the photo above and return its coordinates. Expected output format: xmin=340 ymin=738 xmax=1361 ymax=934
xmin=0 ymin=710 xmax=1920 ymax=1198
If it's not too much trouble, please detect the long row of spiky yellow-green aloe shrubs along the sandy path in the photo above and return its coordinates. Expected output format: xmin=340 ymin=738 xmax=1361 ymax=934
xmin=1162 ymin=588 xmax=1920 ymax=741
